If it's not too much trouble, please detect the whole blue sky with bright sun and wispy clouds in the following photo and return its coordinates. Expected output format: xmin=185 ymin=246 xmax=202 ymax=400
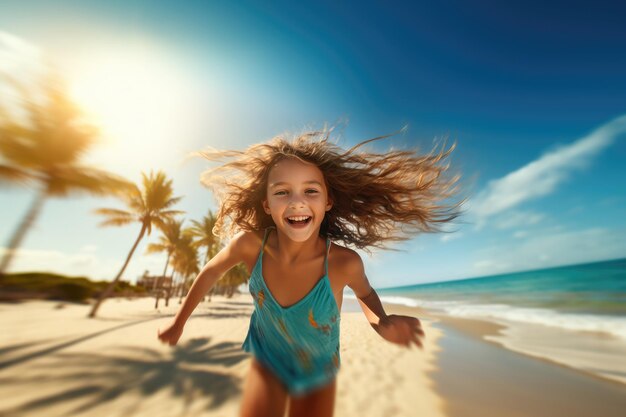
xmin=0 ymin=1 xmax=626 ymax=288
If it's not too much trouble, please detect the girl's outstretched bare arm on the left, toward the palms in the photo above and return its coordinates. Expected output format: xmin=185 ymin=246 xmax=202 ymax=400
xmin=157 ymin=232 xmax=258 ymax=346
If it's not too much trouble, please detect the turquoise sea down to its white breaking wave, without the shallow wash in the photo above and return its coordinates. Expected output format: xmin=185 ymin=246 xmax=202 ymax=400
xmin=377 ymin=259 xmax=626 ymax=340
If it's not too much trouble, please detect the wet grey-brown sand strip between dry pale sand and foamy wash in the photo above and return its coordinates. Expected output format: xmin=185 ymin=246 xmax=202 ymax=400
xmin=376 ymin=303 xmax=626 ymax=417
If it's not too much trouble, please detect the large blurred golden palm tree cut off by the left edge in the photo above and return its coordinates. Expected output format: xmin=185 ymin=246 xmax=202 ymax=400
xmin=0 ymin=76 xmax=130 ymax=280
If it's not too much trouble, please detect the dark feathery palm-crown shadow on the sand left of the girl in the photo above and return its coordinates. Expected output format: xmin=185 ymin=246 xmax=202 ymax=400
xmin=0 ymin=338 xmax=248 ymax=415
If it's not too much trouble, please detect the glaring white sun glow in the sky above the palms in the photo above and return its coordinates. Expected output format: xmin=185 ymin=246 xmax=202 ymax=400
xmin=69 ymin=50 xmax=193 ymax=175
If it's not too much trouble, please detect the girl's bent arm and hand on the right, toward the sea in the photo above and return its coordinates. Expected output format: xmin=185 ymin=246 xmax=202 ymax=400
xmin=344 ymin=252 xmax=424 ymax=349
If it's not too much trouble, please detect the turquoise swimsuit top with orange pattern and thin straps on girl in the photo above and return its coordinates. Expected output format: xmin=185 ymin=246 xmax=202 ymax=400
xmin=241 ymin=229 xmax=341 ymax=396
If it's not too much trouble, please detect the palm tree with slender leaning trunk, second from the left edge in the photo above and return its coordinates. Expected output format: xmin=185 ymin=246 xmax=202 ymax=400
xmin=89 ymin=171 xmax=183 ymax=317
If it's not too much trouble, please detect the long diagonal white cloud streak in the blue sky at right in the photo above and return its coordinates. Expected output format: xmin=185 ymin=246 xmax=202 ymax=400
xmin=467 ymin=115 xmax=626 ymax=229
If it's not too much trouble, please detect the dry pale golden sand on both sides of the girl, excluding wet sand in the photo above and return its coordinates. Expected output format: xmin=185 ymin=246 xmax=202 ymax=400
xmin=0 ymin=295 xmax=445 ymax=417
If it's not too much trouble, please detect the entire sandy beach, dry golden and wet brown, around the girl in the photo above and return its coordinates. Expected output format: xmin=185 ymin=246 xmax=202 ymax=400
xmin=0 ymin=294 xmax=626 ymax=417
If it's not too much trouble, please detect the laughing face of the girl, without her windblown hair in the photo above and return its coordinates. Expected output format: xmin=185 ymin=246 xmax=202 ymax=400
xmin=263 ymin=158 xmax=332 ymax=242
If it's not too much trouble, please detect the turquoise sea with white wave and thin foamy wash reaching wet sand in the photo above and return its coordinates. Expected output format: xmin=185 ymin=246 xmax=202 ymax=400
xmin=366 ymin=259 xmax=626 ymax=384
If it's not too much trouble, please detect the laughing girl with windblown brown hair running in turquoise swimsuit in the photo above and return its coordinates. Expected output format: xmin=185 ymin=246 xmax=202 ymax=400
xmin=158 ymin=131 xmax=461 ymax=417
